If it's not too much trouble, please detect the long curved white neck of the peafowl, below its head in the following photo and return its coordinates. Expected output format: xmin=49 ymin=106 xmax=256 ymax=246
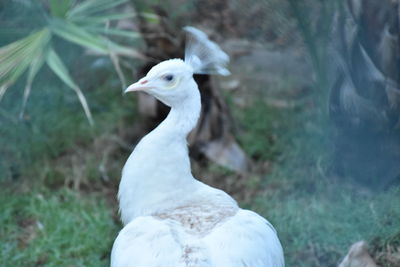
xmin=119 ymin=85 xmax=201 ymax=224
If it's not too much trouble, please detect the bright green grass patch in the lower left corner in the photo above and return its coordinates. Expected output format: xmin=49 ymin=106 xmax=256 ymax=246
xmin=0 ymin=188 xmax=118 ymax=267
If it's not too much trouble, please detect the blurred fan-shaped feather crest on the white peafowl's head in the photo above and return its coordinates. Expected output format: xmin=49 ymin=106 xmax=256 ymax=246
xmin=183 ymin=26 xmax=230 ymax=76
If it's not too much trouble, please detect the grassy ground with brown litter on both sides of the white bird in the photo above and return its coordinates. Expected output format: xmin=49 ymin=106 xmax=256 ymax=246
xmin=0 ymin=39 xmax=400 ymax=266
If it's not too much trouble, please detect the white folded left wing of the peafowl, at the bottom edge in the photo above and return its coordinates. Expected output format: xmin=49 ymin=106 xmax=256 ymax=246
xmin=111 ymin=216 xmax=185 ymax=267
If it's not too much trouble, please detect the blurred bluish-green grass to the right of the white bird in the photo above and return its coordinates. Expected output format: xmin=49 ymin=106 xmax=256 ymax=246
xmin=240 ymin=95 xmax=400 ymax=266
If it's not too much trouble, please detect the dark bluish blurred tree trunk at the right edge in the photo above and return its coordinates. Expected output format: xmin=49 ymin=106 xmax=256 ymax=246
xmin=330 ymin=0 xmax=400 ymax=187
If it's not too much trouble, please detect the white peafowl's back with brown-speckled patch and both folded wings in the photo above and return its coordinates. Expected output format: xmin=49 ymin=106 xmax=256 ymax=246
xmin=111 ymin=203 xmax=284 ymax=267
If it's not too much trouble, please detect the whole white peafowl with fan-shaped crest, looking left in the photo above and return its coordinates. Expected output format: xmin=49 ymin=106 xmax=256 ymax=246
xmin=111 ymin=26 xmax=284 ymax=267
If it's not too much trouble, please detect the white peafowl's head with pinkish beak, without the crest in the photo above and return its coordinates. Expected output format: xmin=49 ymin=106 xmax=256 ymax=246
xmin=125 ymin=59 xmax=198 ymax=107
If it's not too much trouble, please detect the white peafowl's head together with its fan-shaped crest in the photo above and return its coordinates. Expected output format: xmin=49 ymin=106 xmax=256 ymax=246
xmin=125 ymin=27 xmax=229 ymax=107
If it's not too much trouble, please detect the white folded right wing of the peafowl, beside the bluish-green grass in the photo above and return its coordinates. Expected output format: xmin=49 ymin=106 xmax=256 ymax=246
xmin=203 ymin=210 xmax=285 ymax=267
